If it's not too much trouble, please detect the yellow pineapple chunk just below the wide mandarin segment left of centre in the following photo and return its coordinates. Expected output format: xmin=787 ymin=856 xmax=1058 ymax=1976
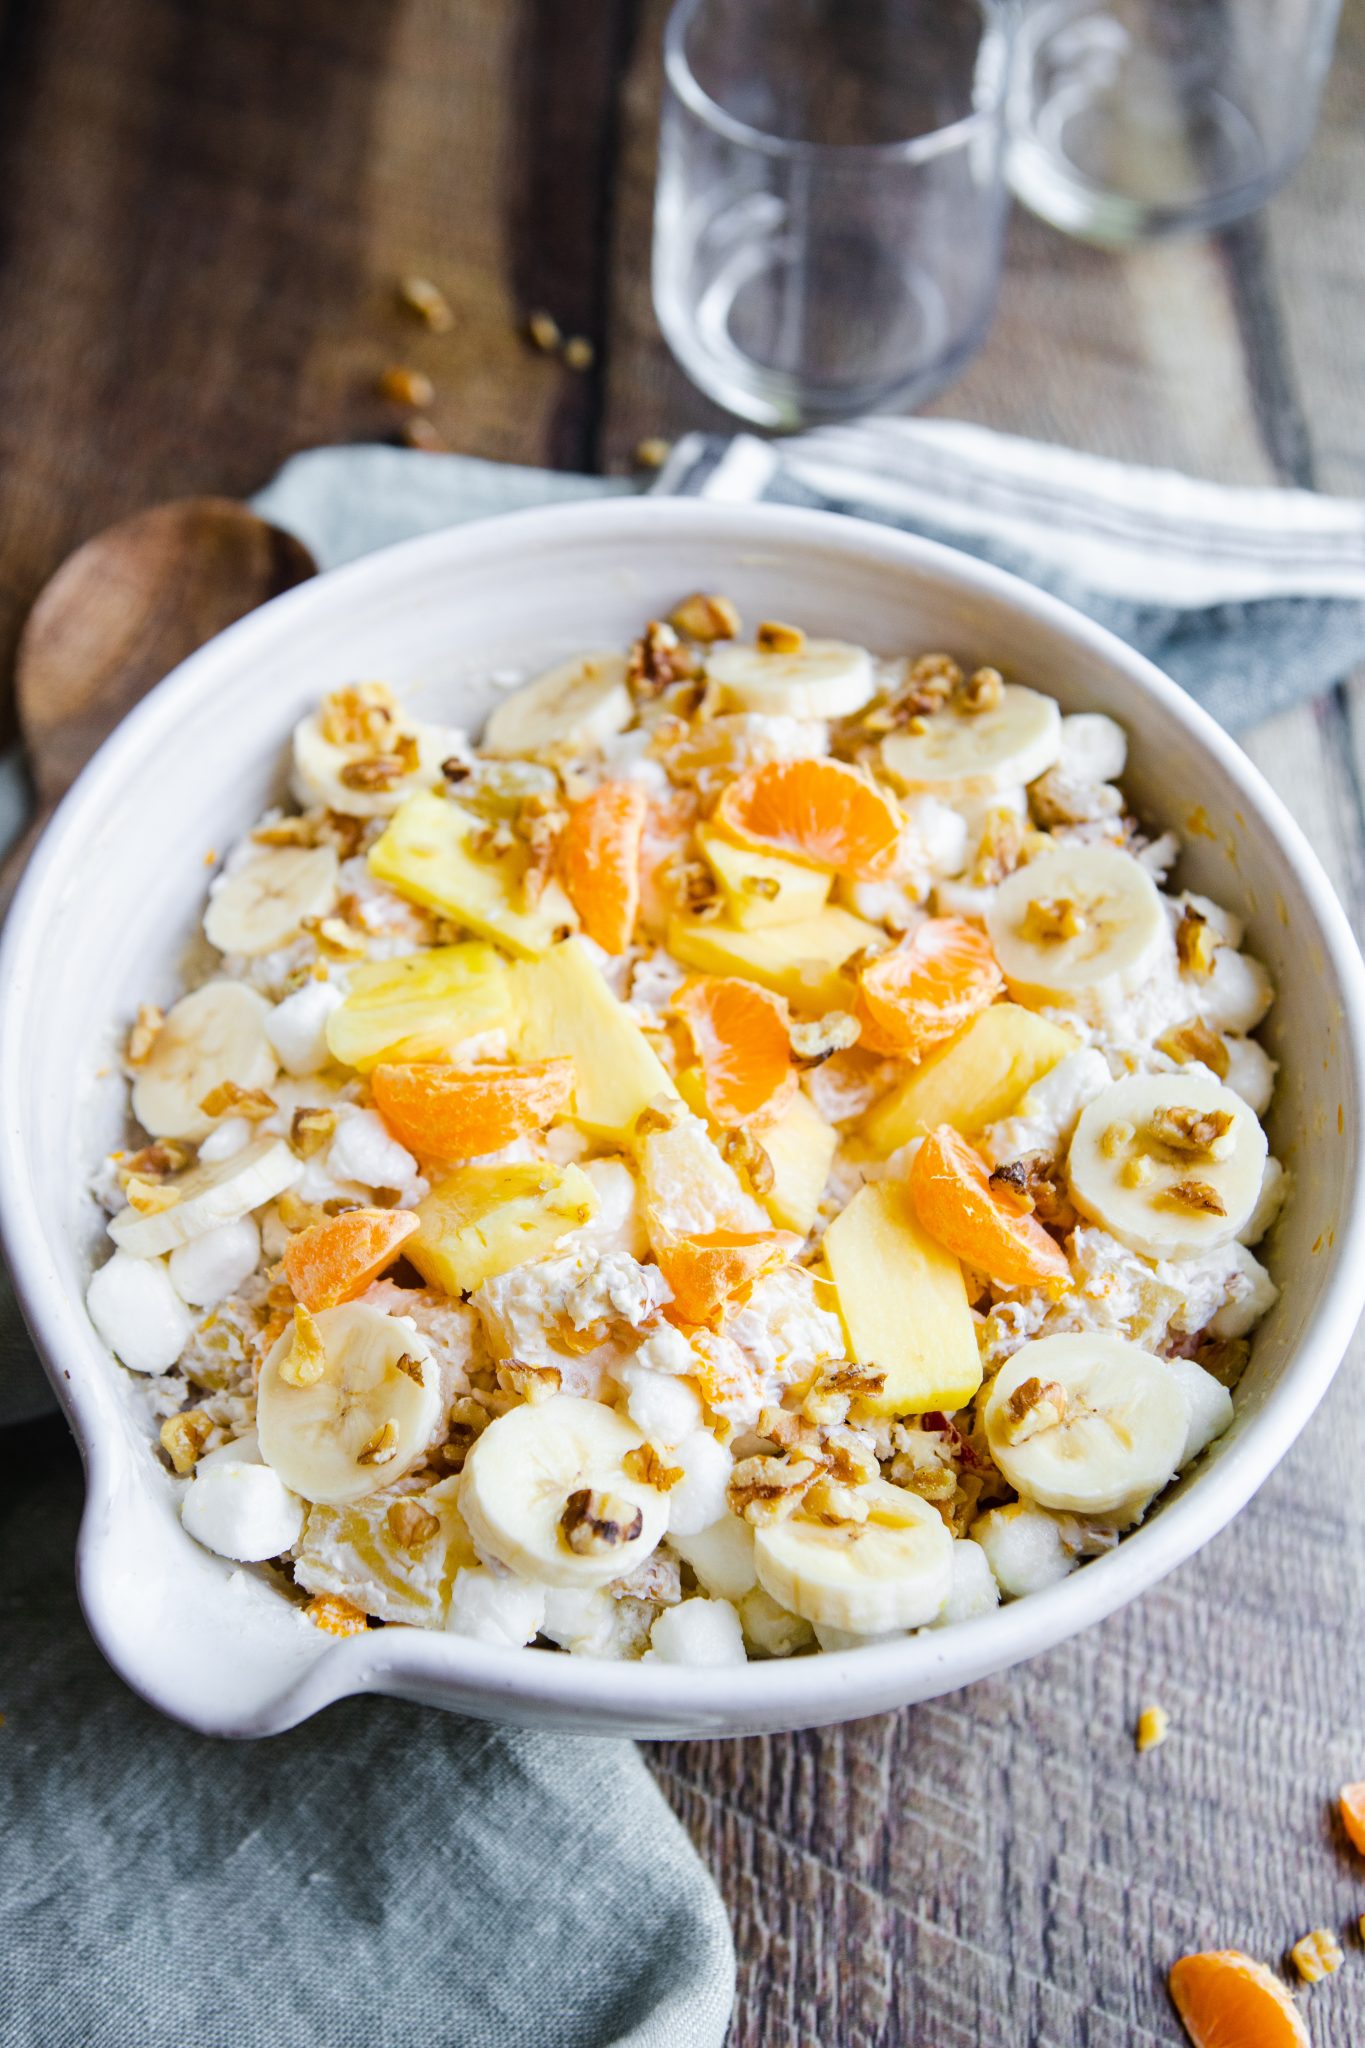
xmin=403 ymin=1163 xmax=598 ymax=1296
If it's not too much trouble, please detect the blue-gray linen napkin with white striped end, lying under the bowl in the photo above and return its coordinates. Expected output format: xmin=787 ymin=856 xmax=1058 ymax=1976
xmin=0 ymin=420 xmax=1365 ymax=2048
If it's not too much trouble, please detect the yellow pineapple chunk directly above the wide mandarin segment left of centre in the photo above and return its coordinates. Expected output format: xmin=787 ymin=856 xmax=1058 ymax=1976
xmin=327 ymin=940 xmax=512 ymax=1073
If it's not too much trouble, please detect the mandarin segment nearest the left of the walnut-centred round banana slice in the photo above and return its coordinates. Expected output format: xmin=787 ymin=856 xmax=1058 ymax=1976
xmin=855 ymin=918 xmax=1005 ymax=1061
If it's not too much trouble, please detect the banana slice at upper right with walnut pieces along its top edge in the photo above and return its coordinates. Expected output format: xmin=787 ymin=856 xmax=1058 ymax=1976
xmin=882 ymin=682 xmax=1062 ymax=799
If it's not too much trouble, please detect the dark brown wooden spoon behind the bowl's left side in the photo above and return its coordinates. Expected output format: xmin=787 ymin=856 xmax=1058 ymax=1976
xmin=0 ymin=498 xmax=317 ymax=903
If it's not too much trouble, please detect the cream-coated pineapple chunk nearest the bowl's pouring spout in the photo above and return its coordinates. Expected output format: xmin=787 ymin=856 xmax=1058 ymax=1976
xmin=295 ymin=1473 xmax=479 ymax=1628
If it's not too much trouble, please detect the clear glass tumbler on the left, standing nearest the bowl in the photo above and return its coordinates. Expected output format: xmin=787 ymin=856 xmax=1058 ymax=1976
xmin=653 ymin=0 xmax=1013 ymax=428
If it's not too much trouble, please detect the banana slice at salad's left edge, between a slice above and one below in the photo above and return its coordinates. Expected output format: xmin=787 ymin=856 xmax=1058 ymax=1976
xmin=133 ymin=981 xmax=278 ymax=1141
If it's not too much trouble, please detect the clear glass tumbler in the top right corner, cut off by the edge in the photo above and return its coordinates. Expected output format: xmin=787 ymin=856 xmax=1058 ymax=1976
xmin=1009 ymin=0 xmax=1340 ymax=244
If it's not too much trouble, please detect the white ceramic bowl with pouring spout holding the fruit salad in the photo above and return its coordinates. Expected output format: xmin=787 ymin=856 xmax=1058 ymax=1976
xmin=0 ymin=500 xmax=1365 ymax=1735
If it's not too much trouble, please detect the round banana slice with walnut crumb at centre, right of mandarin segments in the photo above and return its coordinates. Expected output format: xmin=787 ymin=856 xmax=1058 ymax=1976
xmin=986 ymin=846 xmax=1173 ymax=1020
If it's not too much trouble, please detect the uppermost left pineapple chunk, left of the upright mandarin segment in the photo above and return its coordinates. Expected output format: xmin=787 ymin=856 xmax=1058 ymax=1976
xmin=368 ymin=791 xmax=577 ymax=958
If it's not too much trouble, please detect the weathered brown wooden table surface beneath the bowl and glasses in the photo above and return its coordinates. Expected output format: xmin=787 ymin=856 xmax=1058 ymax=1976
xmin=0 ymin=0 xmax=1365 ymax=2048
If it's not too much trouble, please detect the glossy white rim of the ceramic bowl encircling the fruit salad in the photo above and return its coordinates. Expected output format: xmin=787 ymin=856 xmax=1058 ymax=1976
xmin=0 ymin=498 xmax=1365 ymax=1735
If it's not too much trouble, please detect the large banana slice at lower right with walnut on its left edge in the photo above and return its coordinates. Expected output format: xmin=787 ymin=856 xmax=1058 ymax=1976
xmin=984 ymin=1333 xmax=1189 ymax=1516
